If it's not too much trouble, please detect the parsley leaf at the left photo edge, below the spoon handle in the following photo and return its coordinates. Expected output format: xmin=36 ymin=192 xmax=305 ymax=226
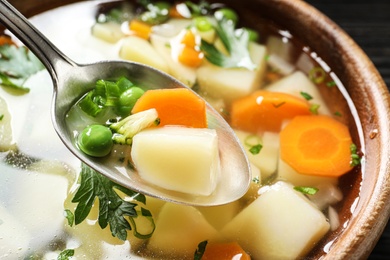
xmin=0 ymin=45 xmax=44 ymax=93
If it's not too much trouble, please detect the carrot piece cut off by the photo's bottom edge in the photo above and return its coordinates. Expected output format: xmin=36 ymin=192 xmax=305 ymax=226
xmin=202 ymin=242 xmax=251 ymax=260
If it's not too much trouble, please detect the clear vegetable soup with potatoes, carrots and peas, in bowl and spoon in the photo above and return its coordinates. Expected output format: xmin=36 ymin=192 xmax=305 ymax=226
xmin=0 ymin=0 xmax=364 ymax=259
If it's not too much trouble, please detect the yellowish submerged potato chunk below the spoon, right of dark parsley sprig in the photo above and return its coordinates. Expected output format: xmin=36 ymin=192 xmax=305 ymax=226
xmin=147 ymin=203 xmax=217 ymax=259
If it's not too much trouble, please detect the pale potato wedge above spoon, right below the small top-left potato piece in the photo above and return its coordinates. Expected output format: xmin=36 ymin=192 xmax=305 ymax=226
xmin=119 ymin=36 xmax=169 ymax=73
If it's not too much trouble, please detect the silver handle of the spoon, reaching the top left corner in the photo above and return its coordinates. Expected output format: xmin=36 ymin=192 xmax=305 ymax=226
xmin=0 ymin=0 xmax=76 ymax=80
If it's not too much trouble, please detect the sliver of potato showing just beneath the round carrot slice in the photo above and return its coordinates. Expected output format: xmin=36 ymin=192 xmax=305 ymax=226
xmin=277 ymin=158 xmax=338 ymax=187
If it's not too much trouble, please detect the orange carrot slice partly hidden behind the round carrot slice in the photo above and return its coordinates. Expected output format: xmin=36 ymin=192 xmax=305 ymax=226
xmin=230 ymin=90 xmax=310 ymax=133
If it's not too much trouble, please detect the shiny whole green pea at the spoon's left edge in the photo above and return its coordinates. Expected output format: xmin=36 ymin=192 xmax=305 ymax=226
xmin=77 ymin=125 xmax=113 ymax=157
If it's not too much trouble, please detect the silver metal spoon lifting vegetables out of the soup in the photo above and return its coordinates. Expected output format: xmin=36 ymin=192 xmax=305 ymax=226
xmin=0 ymin=0 xmax=251 ymax=206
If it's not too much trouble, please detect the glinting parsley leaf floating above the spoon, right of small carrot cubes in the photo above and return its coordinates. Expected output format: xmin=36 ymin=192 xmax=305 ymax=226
xmin=200 ymin=19 xmax=257 ymax=70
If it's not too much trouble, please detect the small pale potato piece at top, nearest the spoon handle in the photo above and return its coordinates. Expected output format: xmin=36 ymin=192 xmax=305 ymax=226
xmin=92 ymin=22 xmax=125 ymax=43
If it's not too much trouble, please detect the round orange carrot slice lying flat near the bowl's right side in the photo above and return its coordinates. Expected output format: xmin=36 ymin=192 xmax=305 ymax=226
xmin=280 ymin=115 xmax=352 ymax=177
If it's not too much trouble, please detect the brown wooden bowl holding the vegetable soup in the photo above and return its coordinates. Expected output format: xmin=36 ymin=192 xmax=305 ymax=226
xmin=5 ymin=0 xmax=390 ymax=259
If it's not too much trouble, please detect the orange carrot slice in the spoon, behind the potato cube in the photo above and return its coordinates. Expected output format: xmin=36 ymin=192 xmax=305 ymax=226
xmin=132 ymin=88 xmax=207 ymax=128
